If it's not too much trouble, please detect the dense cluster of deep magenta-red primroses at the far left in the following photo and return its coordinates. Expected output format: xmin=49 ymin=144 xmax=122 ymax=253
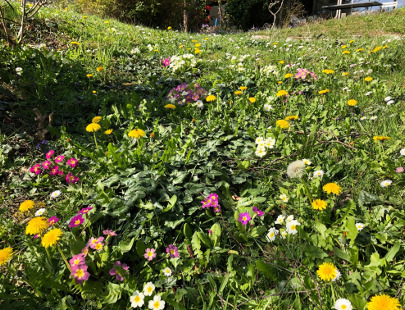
xmin=30 ymin=150 xmax=79 ymax=184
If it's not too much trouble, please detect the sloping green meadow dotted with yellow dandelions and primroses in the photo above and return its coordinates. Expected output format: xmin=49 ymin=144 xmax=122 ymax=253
xmin=0 ymin=8 xmax=405 ymax=310
